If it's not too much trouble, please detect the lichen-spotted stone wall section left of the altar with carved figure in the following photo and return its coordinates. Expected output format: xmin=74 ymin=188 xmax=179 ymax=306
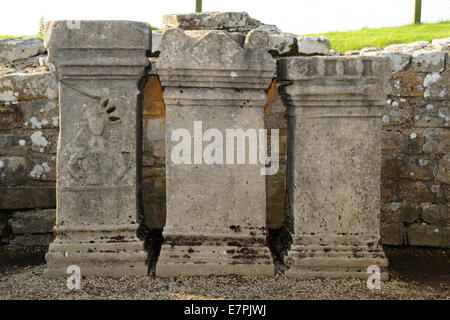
xmin=0 ymin=38 xmax=59 ymax=245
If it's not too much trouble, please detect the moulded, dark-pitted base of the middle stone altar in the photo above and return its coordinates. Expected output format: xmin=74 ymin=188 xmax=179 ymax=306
xmin=156 ymin=229 xmax=274 ymax=277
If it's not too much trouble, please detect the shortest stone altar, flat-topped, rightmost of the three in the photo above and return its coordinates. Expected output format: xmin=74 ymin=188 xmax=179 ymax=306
xmin=278 ymin=57 xmax=391 ymax=278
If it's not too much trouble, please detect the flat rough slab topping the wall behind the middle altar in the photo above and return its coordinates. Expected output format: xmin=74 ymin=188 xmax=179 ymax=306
xmin=162 ymin=12 xmax=263 ymax=32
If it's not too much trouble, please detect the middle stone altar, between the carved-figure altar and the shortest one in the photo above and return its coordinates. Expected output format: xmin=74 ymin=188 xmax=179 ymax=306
xmin=156 ymin=29 xmax=276 ymax=276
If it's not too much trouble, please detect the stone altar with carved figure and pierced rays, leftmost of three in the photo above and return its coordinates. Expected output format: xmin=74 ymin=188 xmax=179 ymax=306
xmin=45 ymin=21 xmax=151 ymax=276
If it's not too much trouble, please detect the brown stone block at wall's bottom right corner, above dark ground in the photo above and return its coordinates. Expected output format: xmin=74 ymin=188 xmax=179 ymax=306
xmin=407 ymin=223 xmax=450 ymax=247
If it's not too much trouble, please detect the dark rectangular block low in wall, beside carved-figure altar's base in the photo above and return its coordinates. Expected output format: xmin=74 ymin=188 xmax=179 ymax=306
xmin=11 ymin=209 xmax=56 ymax=234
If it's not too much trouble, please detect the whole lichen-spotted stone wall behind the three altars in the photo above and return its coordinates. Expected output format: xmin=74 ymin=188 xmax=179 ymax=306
xmin=0 ymin=15 xmax=450 ymax=248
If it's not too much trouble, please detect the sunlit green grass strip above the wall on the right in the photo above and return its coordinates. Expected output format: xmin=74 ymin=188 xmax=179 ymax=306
xmin=308 ymin=20 xmax=450 ymax=52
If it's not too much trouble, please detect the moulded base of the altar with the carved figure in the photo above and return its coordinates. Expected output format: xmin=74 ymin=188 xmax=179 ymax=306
xmin=45 ymin=225 xmax=148 ymax=277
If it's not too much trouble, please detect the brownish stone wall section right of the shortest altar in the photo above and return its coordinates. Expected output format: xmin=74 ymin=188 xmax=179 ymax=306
xmin=381 ymin=39 xmax=450 ymax=248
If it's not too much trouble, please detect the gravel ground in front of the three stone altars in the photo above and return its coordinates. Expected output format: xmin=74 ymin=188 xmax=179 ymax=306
xmin=0 ymin=248 xmax=450 ymax=300
